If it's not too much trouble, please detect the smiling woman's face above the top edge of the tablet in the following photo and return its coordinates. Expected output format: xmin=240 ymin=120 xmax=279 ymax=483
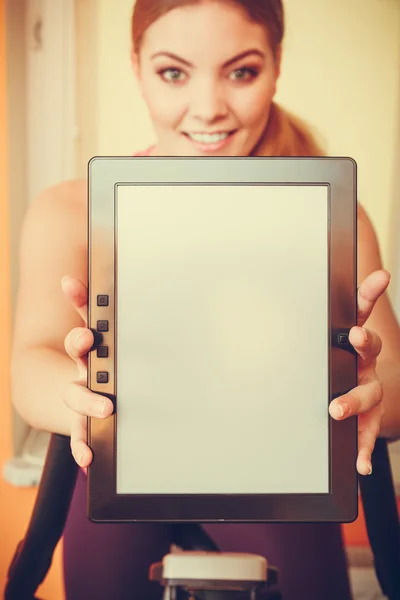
xmin=134 ymin=0 xmax=279 ymax=156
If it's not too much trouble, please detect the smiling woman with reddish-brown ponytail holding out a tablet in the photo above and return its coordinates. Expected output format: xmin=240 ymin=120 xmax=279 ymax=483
xmin=13 ymin=0 xmax=400 ymax=600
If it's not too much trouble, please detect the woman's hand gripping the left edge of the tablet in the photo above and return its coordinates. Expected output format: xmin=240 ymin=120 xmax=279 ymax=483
xmin=61 ymin=276 xmax=114 ymax=467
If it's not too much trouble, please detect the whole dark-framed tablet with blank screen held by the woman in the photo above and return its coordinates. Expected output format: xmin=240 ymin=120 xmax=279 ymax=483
xmin=88 ymin=156 xmax=357 ymax=523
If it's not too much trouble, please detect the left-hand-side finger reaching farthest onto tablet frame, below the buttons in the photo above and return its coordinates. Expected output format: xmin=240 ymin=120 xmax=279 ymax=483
xmin=62 ymin=382 xmax=114 ymax=419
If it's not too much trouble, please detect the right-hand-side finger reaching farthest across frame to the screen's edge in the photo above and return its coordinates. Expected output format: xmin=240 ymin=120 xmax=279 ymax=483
xmin=329 ymin=378 xmax=383 ymax=421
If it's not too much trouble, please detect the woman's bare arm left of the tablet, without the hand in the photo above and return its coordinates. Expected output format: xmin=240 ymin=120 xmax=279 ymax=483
xmin=11 ymin=182 xmax=87 ymax=435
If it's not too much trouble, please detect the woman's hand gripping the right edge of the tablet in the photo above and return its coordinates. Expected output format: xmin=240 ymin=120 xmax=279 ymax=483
xmin=329 ymin=270 xmax=390 ymax=475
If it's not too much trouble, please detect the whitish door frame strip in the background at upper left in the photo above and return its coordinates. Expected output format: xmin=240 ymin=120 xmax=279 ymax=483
xmin=26 ymin=0 xmax=76 ymax=201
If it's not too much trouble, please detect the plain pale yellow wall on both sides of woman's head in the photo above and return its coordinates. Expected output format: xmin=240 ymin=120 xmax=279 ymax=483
xmin=88 ymin=0 xmax=400 ymax=265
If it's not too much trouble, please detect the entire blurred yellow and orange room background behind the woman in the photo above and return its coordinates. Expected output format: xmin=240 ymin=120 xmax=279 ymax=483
xmin=0 ymin=0 xmax=400 ymax=600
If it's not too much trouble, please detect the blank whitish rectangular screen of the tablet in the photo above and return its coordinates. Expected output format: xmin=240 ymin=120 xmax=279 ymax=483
xmin=116 ymin=185 xmax=329 ymax=494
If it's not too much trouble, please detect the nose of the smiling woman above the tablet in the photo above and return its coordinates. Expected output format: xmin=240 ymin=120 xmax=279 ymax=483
xmin=191 ymin=80 xmax=228 ymax=123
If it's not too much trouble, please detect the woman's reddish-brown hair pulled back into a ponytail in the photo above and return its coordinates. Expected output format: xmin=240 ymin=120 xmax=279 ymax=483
xmin=132 ymin=0 xmax=324 ymax=156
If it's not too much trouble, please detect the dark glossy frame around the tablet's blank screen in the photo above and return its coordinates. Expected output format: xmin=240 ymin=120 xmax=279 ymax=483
xmin=87 ymin=156 xmax=358 ymax=523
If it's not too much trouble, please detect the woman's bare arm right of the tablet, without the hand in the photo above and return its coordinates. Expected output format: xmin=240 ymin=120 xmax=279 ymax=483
xmin=358 ymin=205 xmax=400 ymax=438
